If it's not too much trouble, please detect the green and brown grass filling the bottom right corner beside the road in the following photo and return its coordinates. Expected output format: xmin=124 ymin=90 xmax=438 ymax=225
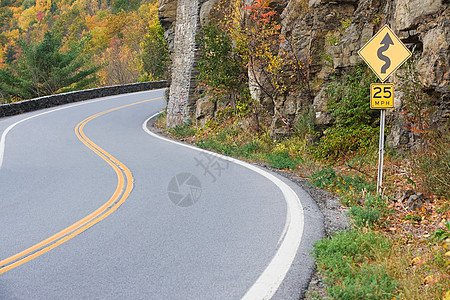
xmin=313 ymin=228 xmax=450 ymax=299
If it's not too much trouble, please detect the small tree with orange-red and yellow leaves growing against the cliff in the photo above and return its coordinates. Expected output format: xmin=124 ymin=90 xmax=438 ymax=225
xmin=244 ymin=0 xmax=313 ymax=133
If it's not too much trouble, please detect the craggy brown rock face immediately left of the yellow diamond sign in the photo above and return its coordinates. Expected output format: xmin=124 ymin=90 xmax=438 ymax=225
xmin=276 ymin=0 xmax=373 ymax=129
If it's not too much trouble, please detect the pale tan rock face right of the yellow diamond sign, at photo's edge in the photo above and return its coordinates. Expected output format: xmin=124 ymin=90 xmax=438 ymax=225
xmin=387 ymin=0 xmax=450 ymax=148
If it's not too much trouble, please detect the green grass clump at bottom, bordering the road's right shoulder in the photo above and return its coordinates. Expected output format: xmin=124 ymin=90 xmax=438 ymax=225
xmin=314 ymin=229 xmax=397 ymax=299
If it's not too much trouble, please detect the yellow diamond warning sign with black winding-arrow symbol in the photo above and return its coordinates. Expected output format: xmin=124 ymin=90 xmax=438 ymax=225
xmin=358 ymin=25 xmax=411 ymax=82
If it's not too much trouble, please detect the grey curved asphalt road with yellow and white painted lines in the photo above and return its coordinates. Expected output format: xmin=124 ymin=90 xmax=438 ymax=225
xmin=0 ymin=90 xmax=322 ymax=299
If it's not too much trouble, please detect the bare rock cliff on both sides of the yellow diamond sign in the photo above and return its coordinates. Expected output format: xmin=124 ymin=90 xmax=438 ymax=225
xmin=278 ymin=0 xmax=450 ymax=147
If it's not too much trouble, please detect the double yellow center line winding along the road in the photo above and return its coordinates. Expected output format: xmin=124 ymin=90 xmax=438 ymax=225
xmin=0 ymin=97 xmax=162 ymax=274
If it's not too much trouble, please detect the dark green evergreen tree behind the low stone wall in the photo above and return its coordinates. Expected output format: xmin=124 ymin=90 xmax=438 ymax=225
xmin=0 ymin=32 xmax=101 ymax=99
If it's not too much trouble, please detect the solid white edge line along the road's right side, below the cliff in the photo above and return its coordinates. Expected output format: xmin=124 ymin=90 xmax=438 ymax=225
xmin=142 ymin=112 xmax=304 ymax=300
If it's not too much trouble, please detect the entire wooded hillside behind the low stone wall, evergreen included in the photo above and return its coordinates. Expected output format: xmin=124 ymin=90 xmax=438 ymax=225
xmin=0 ymin=0 xmax=168 ymax=103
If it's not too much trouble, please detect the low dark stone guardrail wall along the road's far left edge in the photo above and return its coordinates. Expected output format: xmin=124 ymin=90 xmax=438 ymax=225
xmin=0 ymin=81 xmax=168 ymax=118
